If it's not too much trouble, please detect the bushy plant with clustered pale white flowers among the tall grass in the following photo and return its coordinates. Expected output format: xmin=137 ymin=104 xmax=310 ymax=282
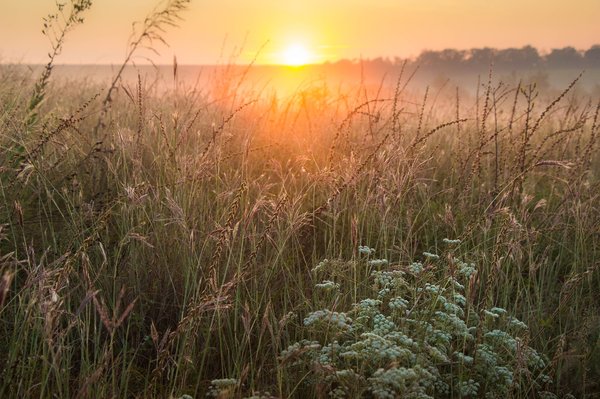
xmin=281 ymin=244 xmax=554 ymax=399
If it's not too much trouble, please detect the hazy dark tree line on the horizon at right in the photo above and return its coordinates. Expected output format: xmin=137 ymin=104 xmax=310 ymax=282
xmin=328 ymin=45 xmax=600 ymax=70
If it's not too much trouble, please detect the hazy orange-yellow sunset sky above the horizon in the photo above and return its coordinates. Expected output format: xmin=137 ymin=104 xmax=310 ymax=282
xmin=0 ymin=0 xmax=600 ymax=64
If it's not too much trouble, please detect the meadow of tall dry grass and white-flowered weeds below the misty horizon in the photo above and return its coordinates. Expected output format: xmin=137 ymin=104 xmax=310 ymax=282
xmin=0 ymin=1 xmax=600 ymax=398
